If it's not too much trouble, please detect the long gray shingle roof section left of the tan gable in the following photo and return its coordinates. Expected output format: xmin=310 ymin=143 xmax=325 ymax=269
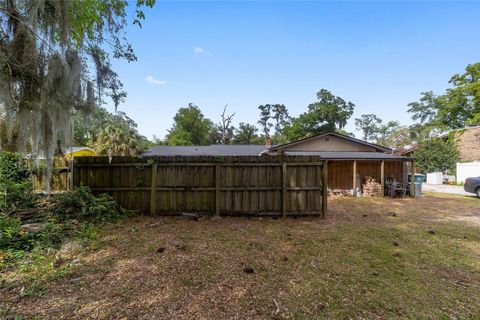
xmin=143 ymin=144 xmax=267 ymax=157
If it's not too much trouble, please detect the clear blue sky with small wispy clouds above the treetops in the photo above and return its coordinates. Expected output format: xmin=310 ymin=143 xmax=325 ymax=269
xmin=109 ymin=0 xmax=480 ymax=138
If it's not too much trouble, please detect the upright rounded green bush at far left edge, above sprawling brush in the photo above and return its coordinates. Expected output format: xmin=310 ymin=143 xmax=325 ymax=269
xmin=0 ymin=151 xmax=35 ymax=210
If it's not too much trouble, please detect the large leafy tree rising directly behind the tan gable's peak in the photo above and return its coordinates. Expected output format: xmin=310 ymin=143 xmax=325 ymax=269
xmin=286 ymin=89 xmax=355 ymax=141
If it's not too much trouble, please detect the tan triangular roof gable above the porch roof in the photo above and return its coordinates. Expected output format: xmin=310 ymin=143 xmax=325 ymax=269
xmin=268 ymin=132 xmax=392 ymax=153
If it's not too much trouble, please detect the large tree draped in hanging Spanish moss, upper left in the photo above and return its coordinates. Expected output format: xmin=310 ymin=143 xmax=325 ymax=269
xmin=0 ymin=0 xmax=155 ymax=182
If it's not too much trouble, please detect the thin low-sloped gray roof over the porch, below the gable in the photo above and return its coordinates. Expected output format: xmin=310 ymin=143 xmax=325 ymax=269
xmin=285 ymin=151 xmax=413 ymax=160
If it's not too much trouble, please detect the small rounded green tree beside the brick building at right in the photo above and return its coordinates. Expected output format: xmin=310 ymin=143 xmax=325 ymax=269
xmin=413 ymin=137 xmax=459 ymax=173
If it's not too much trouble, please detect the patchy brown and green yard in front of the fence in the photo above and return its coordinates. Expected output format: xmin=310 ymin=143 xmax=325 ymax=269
xmin=0 ymin=195 xmax=480 ymax=319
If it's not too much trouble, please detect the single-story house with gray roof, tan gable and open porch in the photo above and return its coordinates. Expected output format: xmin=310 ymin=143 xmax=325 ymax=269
xmin=144 ymin=132 xmax=413 ymax=194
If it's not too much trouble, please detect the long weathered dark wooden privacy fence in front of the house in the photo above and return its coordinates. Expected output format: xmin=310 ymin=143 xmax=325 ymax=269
xmin=73 ymin=156 xmax=328 ymax=216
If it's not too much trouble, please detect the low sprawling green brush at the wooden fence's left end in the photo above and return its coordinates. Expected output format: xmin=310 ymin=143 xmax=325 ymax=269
xmin=0 ymin=188 xmax=125 ymax=269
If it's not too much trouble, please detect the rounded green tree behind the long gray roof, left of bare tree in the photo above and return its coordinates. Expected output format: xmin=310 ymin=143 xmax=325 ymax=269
xmin=166 ymin=103 xmax=215 ymax=146
